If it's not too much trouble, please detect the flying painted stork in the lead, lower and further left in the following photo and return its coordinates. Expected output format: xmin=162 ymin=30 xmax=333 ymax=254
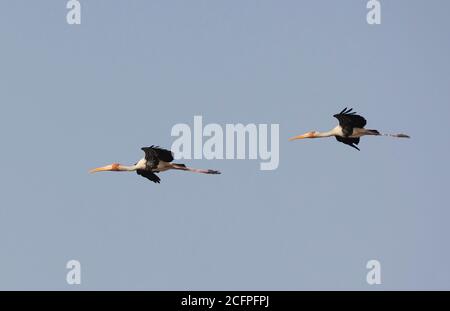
xmin=90 ymin=146 xmax=220 ymax=184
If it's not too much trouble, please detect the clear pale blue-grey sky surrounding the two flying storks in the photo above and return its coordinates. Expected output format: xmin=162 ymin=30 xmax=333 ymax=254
xmin=0 ymin=0 xmax=450 ymax=290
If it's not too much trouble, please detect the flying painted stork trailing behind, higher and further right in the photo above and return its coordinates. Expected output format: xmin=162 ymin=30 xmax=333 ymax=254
xmin=289 ymin=108 xmax=409 ymax=150
